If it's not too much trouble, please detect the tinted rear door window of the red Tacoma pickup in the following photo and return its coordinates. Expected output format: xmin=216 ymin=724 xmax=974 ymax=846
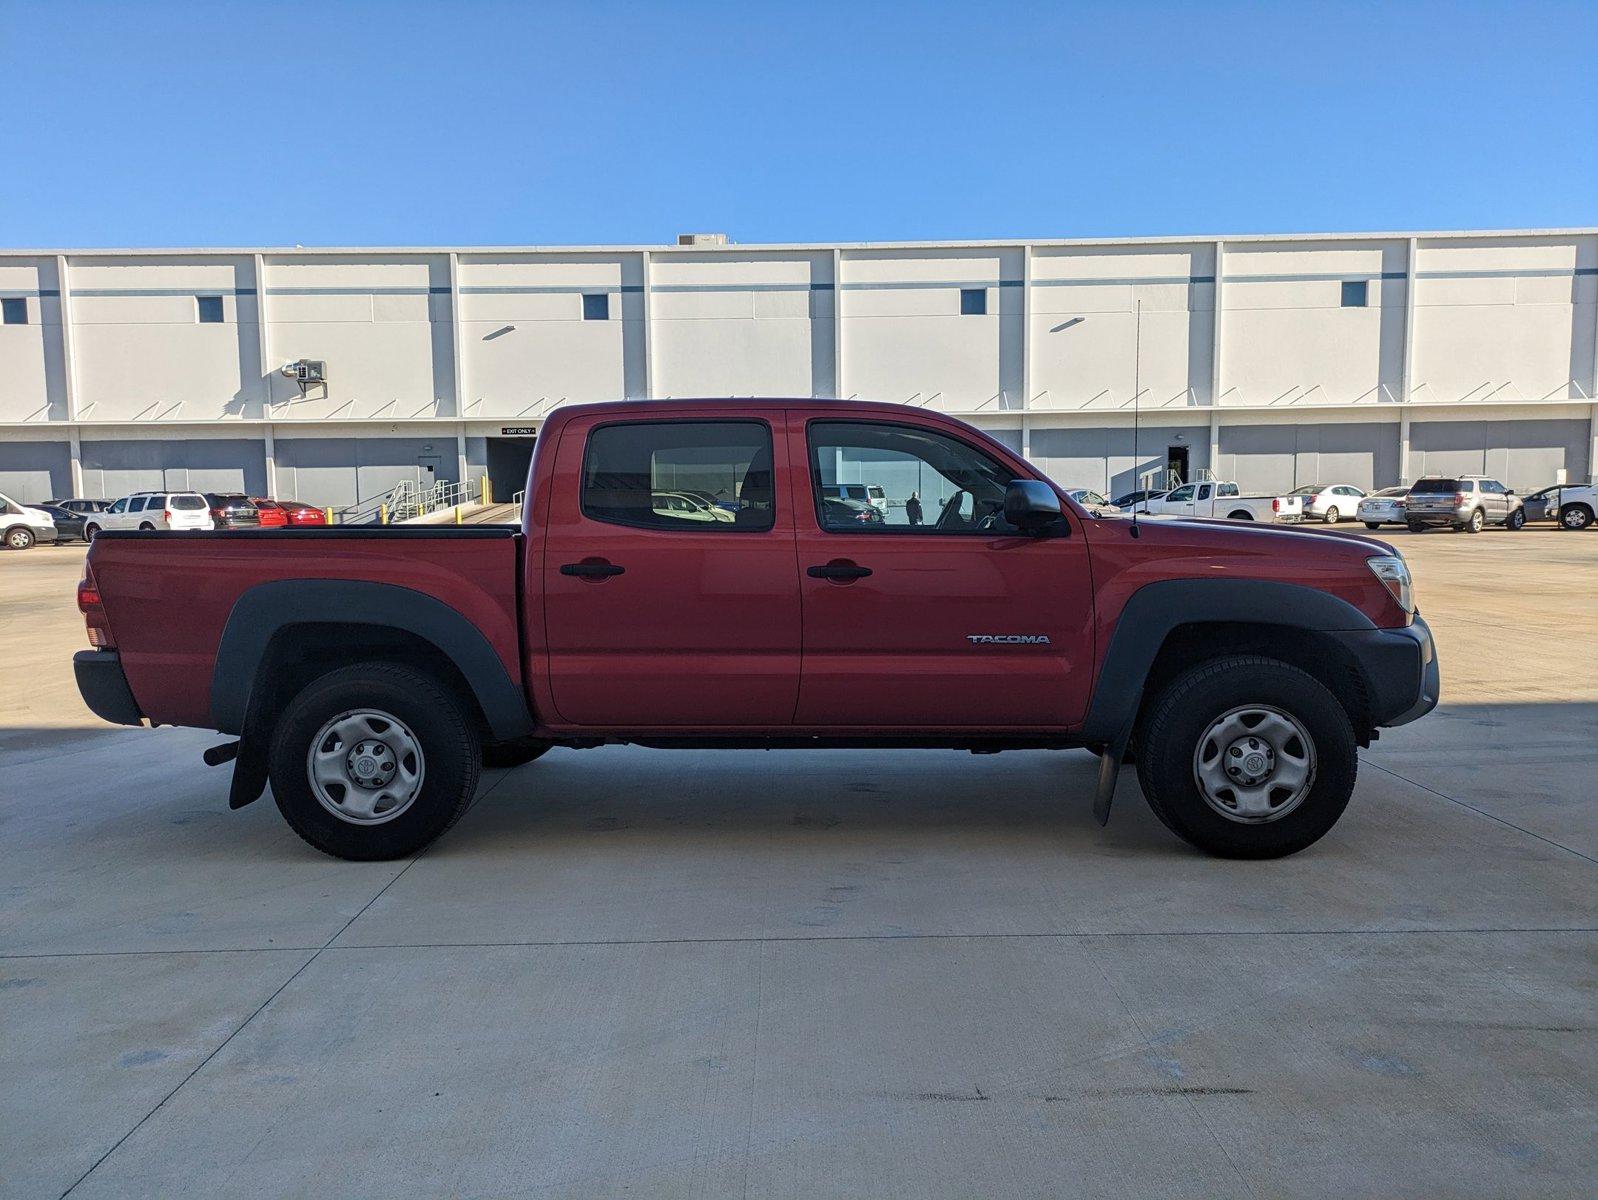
xmin=580 ymin=420 xmax=775 ymax=534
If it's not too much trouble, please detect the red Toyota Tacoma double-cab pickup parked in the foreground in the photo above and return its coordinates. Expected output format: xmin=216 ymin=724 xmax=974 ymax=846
xmin=75 ymin=399 xmax=1438 ymax=860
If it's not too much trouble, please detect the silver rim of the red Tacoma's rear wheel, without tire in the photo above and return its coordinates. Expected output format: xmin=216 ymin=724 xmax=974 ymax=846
xmin=305 ymin=708 xmax=425 ymax=825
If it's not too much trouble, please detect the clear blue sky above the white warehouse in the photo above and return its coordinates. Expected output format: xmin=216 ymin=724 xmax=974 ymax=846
xmin=0 ymin=0 xmax=1598 ymax=246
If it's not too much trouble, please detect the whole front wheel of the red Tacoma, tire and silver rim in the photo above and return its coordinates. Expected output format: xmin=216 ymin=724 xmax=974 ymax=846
xmin=1138 ymin=655 xmax=1358 ymax=858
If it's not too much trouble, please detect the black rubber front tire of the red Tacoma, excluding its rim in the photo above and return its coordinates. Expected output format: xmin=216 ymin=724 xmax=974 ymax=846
xmin=1138 ymin=655 xmax=1358 ymax=858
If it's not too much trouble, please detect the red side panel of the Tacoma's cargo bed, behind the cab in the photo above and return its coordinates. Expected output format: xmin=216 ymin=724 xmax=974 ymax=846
xmin=88 ymin=526 xmax=523 ymax=738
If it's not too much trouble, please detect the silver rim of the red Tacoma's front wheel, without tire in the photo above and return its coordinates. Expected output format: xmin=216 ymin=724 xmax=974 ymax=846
xmin=1194 ymin=705 xmax=1315 ymax=825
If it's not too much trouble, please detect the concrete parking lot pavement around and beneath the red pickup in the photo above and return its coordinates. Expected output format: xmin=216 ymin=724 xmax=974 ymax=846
xmin=0 ymin=526 xmax=1598 ymax=1197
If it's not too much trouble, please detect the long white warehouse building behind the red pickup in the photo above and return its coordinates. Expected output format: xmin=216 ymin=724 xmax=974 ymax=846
xmin=0 ymin=228 xmax=1598 ymax=508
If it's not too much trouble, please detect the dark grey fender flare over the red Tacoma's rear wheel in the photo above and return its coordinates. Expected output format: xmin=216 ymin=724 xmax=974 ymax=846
xmin=211 ymin=578 xmax=534 ymax=741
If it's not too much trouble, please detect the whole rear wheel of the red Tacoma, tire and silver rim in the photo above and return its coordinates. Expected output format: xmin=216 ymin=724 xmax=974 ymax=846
xmin=268 ymin=663 xmax=483 ymax=861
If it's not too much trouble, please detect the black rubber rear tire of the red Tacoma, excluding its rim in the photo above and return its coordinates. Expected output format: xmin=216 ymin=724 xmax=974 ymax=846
xmin=268 ymin=663 xmax=483 ymax=861
